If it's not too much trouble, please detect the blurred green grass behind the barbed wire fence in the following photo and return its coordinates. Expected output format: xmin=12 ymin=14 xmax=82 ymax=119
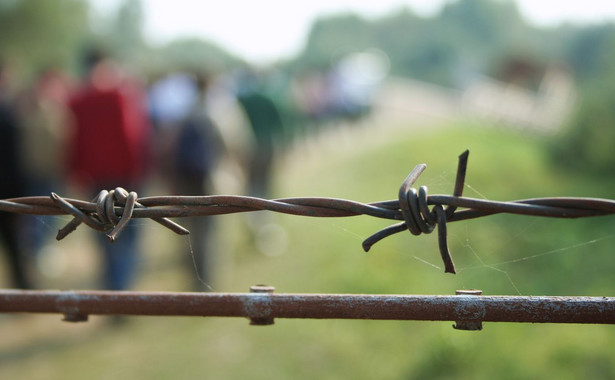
xmin=0 ymin=125 xmax=615 ymax=380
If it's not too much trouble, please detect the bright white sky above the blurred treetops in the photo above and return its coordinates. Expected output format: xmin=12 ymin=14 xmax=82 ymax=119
xmin=90 ymin=0 xmax=615 ymax=62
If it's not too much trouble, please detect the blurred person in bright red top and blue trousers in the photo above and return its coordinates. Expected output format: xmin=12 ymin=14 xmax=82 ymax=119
xmin=68 ymin=50 xmax=149 ymax=290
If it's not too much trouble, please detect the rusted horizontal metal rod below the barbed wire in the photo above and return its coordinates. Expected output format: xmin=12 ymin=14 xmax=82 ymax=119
xmin=0 ymin=286 xmax=615 ymax=329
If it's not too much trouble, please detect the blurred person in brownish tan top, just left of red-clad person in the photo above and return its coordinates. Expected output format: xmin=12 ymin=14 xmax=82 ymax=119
xmin=18 ymin=68 xmax=69 ymax=264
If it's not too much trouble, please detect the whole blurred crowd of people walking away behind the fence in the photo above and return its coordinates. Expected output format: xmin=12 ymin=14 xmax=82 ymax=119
xmin=0 ymin=49 xmax=384 ymax=290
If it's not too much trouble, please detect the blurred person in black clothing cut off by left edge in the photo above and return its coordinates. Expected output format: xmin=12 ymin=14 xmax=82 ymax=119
xmin=0 ymin=62 xmax=32 ymax=289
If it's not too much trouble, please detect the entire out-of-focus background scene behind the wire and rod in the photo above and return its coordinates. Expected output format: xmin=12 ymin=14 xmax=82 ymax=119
xmin=0 ymin=0 xmax=615 ymax=379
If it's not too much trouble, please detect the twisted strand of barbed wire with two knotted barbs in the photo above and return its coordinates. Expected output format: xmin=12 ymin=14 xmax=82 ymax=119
xmin=0 ymin=150 xmax=615 ymax=273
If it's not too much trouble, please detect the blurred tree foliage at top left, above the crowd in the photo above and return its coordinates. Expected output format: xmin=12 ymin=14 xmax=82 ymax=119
xmin=0 ymin=0 xmax=240 ymax=79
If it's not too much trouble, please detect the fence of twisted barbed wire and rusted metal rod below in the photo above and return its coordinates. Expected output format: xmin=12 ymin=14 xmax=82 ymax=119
xmin=0 ymin=151 xmax=615 ymax=330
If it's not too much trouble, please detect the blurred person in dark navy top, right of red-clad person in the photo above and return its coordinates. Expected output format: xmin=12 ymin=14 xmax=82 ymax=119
xmin=173 ymin=75 xmax=225 ymax=290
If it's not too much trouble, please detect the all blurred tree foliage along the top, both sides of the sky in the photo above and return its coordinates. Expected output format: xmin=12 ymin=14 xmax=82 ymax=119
xmin=0 ymin=0 xmax=613 ymax=90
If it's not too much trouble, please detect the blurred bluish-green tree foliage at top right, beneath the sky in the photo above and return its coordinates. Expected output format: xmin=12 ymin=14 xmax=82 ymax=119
xmin=290 ymin=0 xmax=613 ymax=90
